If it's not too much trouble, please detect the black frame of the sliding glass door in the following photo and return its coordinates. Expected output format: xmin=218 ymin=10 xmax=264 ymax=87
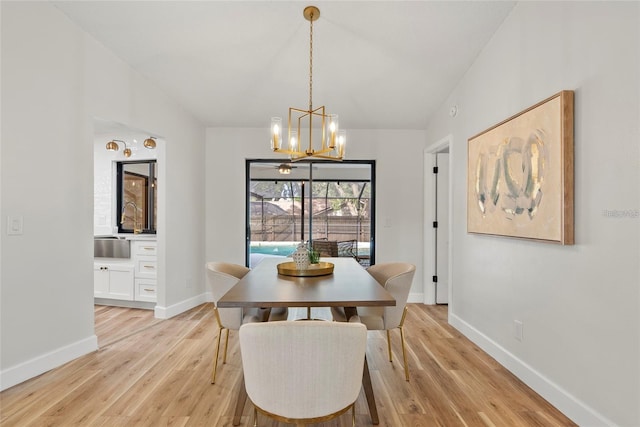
xmin=245 ymin=159 xmax=376 ymax=267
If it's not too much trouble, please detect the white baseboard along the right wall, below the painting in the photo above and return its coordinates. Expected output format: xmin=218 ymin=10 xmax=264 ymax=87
xmin=449 ymin=313 xmax=615 ymax=427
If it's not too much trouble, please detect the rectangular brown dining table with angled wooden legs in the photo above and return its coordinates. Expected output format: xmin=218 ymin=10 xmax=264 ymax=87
xmin=217 ymin=257 xmax=396 ymax=425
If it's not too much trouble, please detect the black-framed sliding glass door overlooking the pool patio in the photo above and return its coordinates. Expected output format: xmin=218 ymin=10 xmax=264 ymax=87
xmin=246 ymin=160 xmax=375 ymax=266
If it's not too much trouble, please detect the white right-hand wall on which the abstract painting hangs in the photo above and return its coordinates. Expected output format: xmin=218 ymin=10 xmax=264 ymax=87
xmin=427 ymin=2 xmax=640 ymax=426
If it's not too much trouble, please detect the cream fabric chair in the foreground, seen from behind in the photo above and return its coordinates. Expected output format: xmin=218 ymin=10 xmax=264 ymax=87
xmin=239 ymin=320 xmax=367 ymax=426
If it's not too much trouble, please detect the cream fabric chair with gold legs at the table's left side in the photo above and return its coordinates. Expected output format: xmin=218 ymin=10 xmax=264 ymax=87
xmin=206 ymin=262 xmax=288 ymax=384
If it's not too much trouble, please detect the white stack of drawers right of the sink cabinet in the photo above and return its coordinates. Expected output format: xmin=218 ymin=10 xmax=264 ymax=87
xmin=131 ymin=240 xmax=158 ymax=302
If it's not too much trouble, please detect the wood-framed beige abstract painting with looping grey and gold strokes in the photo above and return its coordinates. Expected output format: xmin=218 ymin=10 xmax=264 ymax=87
xmin=467 ymin=90 xmax=574 ymax=245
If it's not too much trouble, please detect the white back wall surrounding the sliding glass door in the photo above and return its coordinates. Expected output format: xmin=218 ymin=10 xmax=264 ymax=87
xmin=206 ymin=129 xmax=425 ymax=301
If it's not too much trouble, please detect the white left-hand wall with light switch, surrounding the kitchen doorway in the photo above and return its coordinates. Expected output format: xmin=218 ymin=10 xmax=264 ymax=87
xmin=0 ymin=2 xmax=204 ymax=389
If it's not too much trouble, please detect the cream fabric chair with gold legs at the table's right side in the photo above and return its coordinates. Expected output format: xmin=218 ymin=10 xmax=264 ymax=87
xmin=331 ymin=262 xmax=416 ymax=381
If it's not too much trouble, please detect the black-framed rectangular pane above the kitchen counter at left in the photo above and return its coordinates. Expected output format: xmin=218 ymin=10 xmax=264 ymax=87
xmin=116 ymin=160 xmax=158 ymax=234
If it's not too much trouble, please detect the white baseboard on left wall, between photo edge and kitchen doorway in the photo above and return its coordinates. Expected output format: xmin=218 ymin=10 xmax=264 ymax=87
xmin=0 ymin=335 xmax=98 ymax=391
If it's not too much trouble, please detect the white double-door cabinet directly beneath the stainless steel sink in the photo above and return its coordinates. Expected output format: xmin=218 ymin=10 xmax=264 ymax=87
xmin=93 ymin=262 xmax=134 ymax=300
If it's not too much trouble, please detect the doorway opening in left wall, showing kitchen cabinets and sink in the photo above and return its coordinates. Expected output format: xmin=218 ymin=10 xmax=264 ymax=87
xmin=93 ymin=118 xmax=166 ymax=346
